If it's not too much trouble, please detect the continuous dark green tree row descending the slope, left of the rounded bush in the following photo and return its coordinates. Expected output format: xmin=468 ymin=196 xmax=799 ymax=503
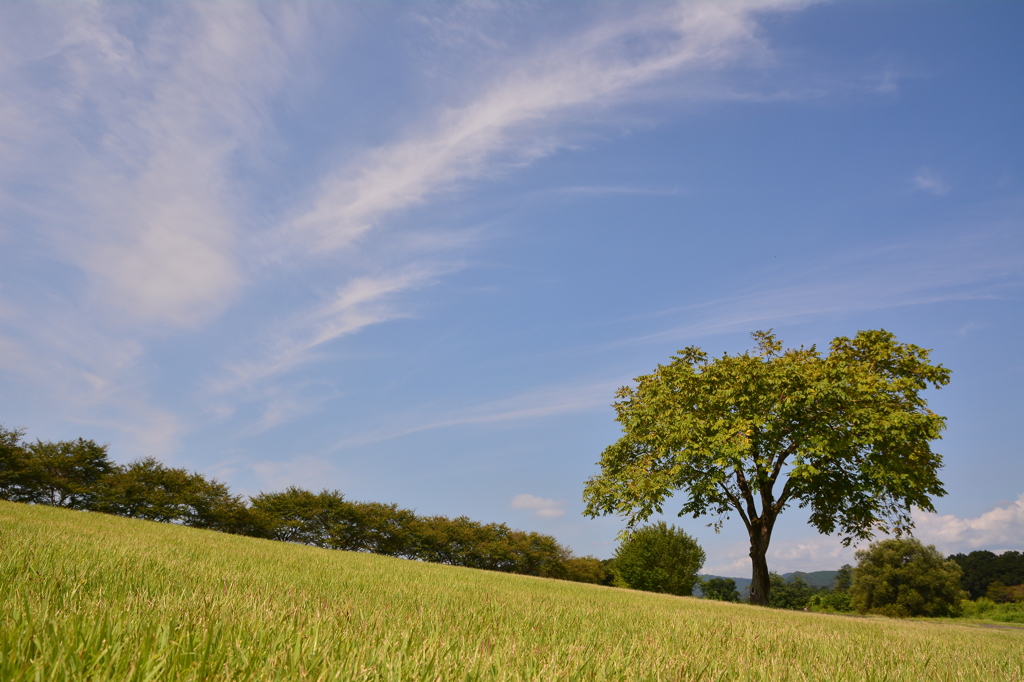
xmin=0 ymin=427 xmax=608 ymax=583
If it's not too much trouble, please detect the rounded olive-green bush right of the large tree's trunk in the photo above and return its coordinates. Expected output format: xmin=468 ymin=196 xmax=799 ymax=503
xmin=850 ymin=539 xmax=967 ymax=617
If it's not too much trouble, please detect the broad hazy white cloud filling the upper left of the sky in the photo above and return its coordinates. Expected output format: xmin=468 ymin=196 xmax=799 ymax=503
xmin=0 ymin=3 xmax=315 ymax=454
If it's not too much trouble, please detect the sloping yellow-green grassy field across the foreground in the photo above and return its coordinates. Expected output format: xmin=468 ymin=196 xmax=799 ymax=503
xmin=0 ymin=502 xmax=1024 ymax=682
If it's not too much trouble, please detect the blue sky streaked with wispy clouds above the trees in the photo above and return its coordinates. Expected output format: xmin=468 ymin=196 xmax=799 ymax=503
xmin=0 ymin=0 xmax=1024 ymax=576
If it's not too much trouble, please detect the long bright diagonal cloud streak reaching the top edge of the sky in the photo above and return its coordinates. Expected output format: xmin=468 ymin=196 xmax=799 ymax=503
xmin=288 ymin=2 xmax=792 ymax=251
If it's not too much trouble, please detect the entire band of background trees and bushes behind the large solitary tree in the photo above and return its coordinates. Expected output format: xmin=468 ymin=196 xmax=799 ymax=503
xmin=6 ymin=426 xmax=1024 ymax=616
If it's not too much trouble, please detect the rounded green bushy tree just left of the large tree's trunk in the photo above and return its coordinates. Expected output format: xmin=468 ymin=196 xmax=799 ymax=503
xmin=611 ymin=521 xmax=705 ymax=597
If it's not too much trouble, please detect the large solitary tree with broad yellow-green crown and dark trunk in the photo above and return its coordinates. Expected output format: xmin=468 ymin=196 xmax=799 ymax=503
xmin=584 ymin=330 xmax=949 ymax=605
